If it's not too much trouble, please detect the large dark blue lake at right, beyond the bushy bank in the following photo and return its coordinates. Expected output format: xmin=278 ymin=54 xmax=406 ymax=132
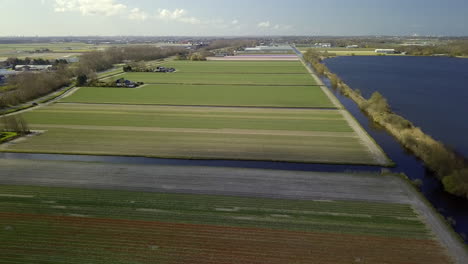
xmin=325 ymin=56 xmax=468 ymax=157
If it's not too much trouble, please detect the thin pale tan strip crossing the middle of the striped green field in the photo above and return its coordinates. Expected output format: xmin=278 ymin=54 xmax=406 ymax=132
xmin=30 ymin=124 xmax=356 ymax=138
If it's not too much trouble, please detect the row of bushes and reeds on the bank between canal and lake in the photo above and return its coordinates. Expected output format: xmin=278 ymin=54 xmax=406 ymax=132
xmin=304 ymin=50 xmax=468 ymax=198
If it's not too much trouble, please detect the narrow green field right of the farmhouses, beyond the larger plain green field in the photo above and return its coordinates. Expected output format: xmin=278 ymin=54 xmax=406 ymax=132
xmin=107 ymin=72 xmax=316 ymax=86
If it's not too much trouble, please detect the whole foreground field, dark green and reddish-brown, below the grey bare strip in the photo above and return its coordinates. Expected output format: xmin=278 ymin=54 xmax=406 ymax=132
xmin=0 ymin=185 xmax=450 ymax=264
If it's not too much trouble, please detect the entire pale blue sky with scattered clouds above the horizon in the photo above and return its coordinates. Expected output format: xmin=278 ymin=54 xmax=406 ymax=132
xmin=0 ymin=0 xmax=468 ymax=36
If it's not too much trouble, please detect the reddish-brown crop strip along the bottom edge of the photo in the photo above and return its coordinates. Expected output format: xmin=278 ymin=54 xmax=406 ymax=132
xmin=0 ymin=213 xmax=450 ymax=264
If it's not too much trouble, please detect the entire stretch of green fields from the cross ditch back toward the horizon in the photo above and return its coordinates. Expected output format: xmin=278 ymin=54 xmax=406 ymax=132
xmin=0 ymin=61 xmax=390 ymax=165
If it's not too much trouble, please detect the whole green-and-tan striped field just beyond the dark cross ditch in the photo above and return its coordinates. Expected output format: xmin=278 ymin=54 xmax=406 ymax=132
xmin=4 ymin=104 xmax=379 ymax=164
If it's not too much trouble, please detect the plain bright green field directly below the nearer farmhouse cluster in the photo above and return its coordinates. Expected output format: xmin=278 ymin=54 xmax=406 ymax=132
xmin=63 ymin=84 xmax=334 ymax=108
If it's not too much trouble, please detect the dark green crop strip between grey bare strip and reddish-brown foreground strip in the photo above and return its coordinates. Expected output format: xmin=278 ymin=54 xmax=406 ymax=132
xmin=0 ymin=185 xmax=432 ymax=239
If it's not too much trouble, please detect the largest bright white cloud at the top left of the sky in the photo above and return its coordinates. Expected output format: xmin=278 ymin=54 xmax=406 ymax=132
xmin=54 ymin=0 xmax=127 ymax=16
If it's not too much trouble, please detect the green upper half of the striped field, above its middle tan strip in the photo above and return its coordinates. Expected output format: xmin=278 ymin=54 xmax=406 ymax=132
xmin=24 ymin=104 xmax=353 ymax=133
